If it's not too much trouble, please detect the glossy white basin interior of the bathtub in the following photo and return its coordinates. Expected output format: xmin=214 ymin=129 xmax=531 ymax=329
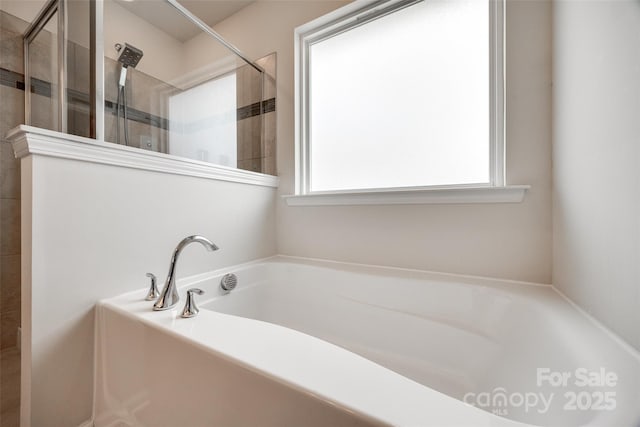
xmin=201 ymin=262 xmax=640 ymax=426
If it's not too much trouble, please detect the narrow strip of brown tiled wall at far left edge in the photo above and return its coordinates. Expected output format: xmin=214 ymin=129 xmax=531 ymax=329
xmin=0 ymin=11 xmax=27 ymax=349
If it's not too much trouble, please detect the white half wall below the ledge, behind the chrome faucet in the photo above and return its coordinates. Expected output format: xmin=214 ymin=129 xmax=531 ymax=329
xmin=22 ymin=145 xmax=276 ymax=427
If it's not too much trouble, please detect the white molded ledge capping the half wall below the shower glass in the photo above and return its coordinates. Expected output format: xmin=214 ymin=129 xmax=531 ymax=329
xmin=6 ymin=125 xmax=279 ymax=187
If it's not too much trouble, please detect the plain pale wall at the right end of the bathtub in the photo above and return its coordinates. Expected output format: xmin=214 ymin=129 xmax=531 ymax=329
xmin=553 ymin=0 xmax=640 ymax=349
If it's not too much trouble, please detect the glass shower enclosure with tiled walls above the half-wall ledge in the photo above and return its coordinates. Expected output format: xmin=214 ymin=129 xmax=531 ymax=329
xmin=24 ymin=0 xmax=276 ymax=175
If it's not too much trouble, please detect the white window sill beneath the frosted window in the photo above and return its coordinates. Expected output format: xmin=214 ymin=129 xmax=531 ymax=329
xmin=282 ymin=185 xmax=530 ymax=206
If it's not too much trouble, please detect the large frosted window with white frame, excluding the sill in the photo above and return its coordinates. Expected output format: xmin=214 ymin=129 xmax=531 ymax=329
xmin=296 ymin=0 xmax=504 ymax=195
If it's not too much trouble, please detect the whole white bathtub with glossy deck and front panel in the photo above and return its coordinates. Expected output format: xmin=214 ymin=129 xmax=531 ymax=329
xmin=94 ymin=257 xmax=640 ymax=427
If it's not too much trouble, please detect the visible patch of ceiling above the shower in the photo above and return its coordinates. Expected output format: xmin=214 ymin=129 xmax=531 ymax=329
xmin=115 ymin=0 xmax=255 ymax=42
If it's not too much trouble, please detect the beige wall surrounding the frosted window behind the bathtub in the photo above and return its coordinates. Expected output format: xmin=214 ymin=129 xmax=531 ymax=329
xmin=215 ymin=1 xmax=551 ymax=283
